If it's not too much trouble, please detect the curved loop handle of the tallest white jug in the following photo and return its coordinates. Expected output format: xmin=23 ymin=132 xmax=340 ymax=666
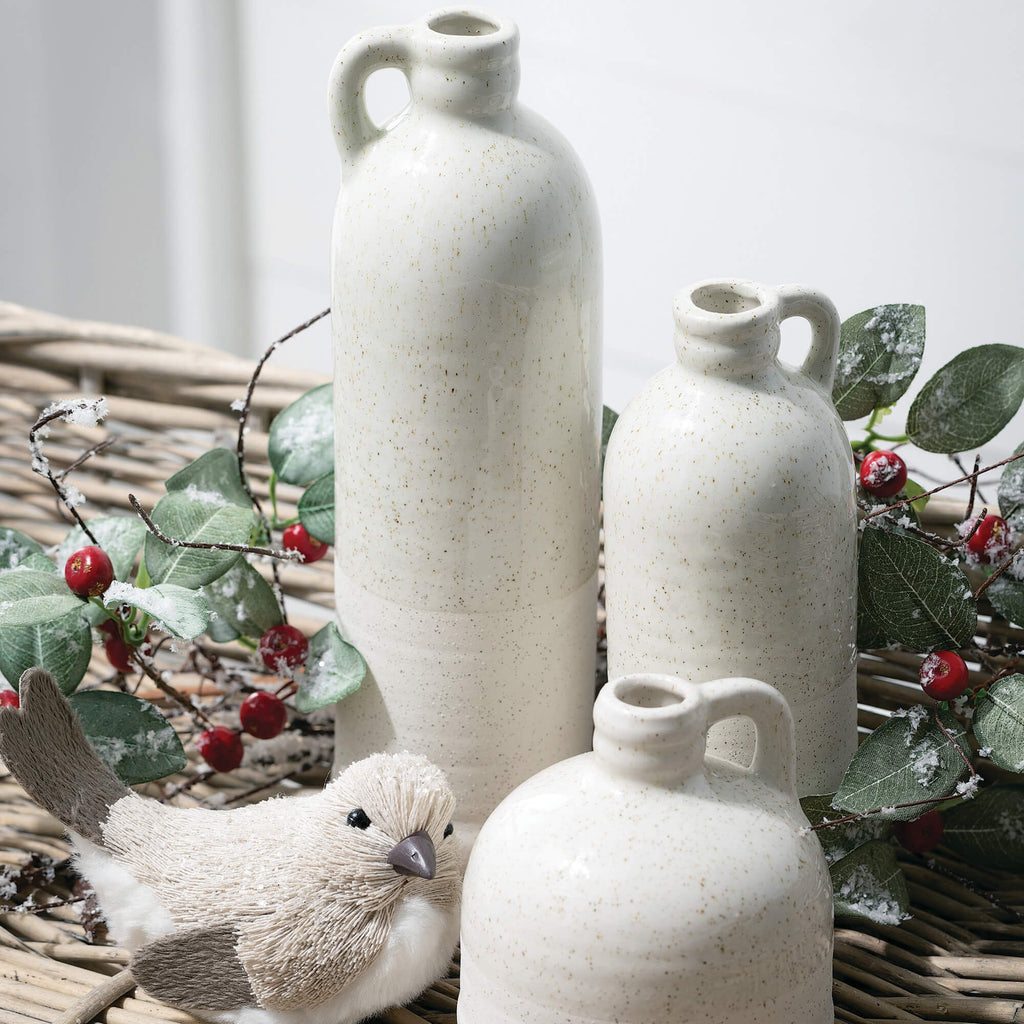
xmin=328 ymin=26 xmax=413 ymax=163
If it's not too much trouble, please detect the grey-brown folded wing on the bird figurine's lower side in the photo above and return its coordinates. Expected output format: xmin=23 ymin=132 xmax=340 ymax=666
xmin=130 ymin=924 xmax=256 ymax=1011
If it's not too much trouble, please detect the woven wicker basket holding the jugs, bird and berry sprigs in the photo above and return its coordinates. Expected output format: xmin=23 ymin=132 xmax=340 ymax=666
xmin=0 ymin=304 xmax=1024 ymax=1024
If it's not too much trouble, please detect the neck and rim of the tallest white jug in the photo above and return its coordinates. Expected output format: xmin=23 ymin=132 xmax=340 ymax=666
xmin=409 ymin=8 xmax=519 ymax=117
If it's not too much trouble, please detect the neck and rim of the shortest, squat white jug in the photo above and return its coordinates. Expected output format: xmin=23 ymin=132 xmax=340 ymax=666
xmin=594 ymin=673 xmax=708 ymax=786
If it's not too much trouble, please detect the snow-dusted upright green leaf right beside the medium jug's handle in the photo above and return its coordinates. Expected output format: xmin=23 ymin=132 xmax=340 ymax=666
xmin=833 ymin=304 xmax=925 ymax=420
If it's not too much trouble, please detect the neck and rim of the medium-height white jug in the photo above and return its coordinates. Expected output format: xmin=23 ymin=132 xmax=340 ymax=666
xmin=675 ymin=279 xmax=781 ymax=378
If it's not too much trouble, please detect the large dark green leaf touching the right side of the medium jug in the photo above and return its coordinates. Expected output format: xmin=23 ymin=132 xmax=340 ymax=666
xmin=857 ymin=525 xmax=978 ymax=651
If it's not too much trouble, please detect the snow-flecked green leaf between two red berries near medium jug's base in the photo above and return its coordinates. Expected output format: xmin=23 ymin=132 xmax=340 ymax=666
xmin=834 ymin=707 xmax=967 ymax=821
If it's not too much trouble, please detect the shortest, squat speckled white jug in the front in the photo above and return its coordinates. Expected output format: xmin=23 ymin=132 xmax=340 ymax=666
xmin=459 ymin=675 xmax=834 ymax=1024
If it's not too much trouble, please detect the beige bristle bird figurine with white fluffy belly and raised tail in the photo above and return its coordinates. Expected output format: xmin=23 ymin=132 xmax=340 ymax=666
xmin=0 ymin=669 xmax=461 ymax=1024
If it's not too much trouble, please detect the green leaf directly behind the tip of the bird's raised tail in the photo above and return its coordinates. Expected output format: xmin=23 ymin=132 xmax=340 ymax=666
xmin=0 ymin=607 xmax=92 ymax=693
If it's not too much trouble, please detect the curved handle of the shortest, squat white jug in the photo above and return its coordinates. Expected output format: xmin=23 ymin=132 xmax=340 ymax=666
xmin=699 ymin=677 xmax=797 ymax=799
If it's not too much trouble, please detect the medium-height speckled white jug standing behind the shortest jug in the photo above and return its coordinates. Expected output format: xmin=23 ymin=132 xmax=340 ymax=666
xmin=604 ymin=280 xmax=857 ymax=796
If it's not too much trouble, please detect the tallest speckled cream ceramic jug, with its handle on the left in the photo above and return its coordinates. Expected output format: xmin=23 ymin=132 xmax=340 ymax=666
xmin=331 ymin=9 xmax=601 ymax=826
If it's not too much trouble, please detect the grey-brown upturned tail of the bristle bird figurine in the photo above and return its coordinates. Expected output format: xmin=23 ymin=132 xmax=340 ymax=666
xmin=0 ymin=669 xmax=131 ymax=844
